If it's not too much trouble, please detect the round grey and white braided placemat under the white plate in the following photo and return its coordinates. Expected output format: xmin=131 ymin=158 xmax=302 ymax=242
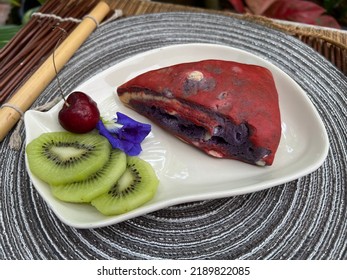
xmin=0 ymin=13 xmax=347 ymax=259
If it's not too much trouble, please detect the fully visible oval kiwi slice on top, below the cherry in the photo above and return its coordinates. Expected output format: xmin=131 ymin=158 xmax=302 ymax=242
xmin=26 ymin=131 xmax=111 ymax=185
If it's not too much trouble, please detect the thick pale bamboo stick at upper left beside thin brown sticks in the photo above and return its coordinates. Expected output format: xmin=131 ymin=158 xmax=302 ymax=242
xmin=0 ymin=1 xmax=110 ymax=141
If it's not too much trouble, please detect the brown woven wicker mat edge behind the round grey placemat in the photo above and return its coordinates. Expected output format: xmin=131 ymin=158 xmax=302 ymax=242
xmin=114 ymin=0 xmax=347 ymax=75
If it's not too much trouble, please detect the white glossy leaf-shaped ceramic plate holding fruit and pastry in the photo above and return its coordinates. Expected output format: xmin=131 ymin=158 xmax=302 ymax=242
xmin=25 ymin=43 xmax=329 ymax=228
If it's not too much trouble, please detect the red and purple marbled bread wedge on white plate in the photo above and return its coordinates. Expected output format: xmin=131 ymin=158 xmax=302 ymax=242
xmin=117 ymin=59 xmax=281 ymax=166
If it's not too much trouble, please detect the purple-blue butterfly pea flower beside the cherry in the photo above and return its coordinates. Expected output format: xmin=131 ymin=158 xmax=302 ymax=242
xmin=96 ymin=112 xmax=151 ymax=156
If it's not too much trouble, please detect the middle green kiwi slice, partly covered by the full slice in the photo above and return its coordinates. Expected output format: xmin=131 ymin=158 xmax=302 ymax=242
xmin=51 ymin=149 xmax=126 ymax=203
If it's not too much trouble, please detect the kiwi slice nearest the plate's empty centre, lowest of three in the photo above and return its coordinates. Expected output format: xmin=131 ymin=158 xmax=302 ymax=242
xmin=91 ymin=156 xmax=159 ymax=215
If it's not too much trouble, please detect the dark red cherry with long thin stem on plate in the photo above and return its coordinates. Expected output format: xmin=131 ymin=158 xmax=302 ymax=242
xmin=58 ymin=91 xmax=100 ymax=133
